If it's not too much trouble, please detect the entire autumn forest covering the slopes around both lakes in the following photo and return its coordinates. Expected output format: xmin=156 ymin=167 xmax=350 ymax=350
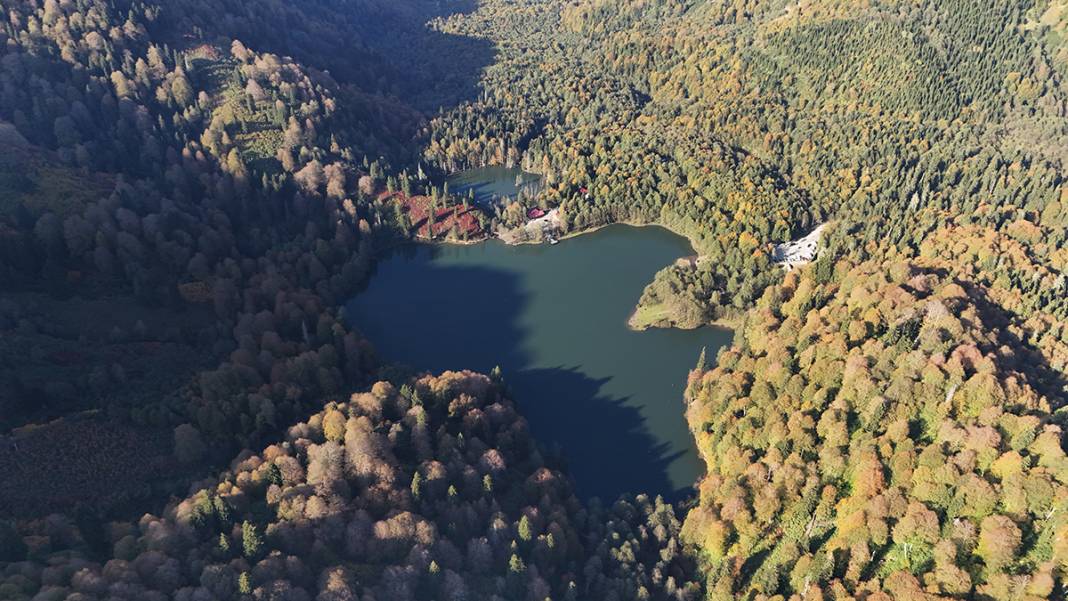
xmin=0 ymin=0 xmax=1068 ymax=601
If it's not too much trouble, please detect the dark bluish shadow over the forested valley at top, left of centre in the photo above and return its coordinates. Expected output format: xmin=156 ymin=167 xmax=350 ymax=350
xmin=168 ymin=0 xmax=496 ymax=112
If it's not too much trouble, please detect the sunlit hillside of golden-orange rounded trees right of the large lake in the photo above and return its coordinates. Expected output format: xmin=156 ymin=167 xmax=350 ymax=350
xmin=684 ymin=232 xmax=1068 ymax=599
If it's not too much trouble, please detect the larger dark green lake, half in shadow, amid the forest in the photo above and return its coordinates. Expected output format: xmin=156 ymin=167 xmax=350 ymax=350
xmin=346 ymin=225 xmax=732 ymax=502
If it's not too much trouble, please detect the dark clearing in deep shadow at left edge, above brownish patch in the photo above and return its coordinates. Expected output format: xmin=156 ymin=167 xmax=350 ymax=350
xmin=0 ymin=286 xmax=214 ymax=433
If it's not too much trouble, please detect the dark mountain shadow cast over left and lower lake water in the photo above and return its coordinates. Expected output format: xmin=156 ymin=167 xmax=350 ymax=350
xmin=346 ymin=246 xmax=685 ymax=502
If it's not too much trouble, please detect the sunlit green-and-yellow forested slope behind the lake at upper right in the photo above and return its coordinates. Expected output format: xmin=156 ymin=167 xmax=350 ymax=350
xmin=427 ymin=0 xmax=1068 ymax=325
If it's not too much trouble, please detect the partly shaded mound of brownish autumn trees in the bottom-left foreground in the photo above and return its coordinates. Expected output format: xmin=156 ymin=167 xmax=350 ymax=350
xmin=0 ymin=371 xmax=701 ymax=601
